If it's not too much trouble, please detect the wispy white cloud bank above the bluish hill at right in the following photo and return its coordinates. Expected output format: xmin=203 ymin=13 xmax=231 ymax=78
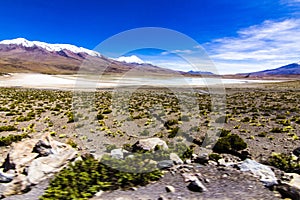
xmin=204 ymin=18 xmax=300 ymax=73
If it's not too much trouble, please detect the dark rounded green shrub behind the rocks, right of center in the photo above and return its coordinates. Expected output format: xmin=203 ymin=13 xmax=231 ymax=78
xmin=213 ymin=134 xmax=247 ymax=153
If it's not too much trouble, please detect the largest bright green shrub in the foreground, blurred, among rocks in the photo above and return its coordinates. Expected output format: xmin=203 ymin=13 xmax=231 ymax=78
xmin=40 ymin=155 xmax=162 ymax=200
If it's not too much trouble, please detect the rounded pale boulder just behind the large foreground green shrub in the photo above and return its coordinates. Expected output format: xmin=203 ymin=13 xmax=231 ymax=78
xmin=132 ymin=138 xmax=168 ymax=151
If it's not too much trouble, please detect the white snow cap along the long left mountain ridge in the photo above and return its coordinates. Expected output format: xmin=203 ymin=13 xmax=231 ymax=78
xmin=0 ymin=38 xmax=100 ymax=56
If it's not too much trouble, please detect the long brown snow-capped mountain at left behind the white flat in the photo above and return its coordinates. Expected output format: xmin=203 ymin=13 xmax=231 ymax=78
xmin=0 ymin=38 xmax=181 ymax=75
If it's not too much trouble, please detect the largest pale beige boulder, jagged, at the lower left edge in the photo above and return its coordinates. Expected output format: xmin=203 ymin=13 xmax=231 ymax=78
xmin=0 ymin=134 xmax=77 ymax=196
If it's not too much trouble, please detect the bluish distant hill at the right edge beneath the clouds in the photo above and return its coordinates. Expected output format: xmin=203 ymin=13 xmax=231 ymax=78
xmin=237 ymin=63 xmax=300 ymax=77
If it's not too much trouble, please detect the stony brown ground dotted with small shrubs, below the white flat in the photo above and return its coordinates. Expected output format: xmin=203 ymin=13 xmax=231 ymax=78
xmin=0 ymin=82 xmax=300 ymax=199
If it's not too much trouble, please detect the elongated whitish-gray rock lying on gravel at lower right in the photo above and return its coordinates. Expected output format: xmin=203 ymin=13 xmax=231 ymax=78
xmin=238 ymin=159 xmax=278 ymax=187
